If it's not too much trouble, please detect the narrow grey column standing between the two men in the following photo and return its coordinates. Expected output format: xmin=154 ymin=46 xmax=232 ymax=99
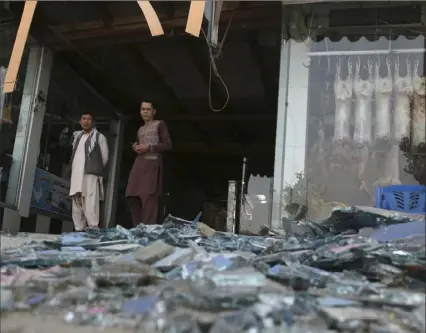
xmin=101 ymin=119 xmax=124 ymax=227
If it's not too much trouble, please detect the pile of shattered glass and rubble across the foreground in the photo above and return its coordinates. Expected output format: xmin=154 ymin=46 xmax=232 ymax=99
xmin=0 ymin=208 xmax=426 ymax=333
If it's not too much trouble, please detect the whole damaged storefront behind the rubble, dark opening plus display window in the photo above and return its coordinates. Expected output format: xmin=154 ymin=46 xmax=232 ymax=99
xmin=1 ymin=1 xmax=425 ymax=232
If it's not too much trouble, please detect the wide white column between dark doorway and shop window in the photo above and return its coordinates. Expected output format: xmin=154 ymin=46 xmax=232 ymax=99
xmin=272 ymin=40 xmax=309 ymax=228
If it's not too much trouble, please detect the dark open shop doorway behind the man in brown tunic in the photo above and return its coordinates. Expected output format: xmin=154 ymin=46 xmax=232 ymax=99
xmin=32 ymin=2 xmax=281 ymax=229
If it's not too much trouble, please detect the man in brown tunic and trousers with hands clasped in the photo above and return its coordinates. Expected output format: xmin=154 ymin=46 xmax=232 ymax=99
xmin=126 ymin=101 xmax=172 ymax=226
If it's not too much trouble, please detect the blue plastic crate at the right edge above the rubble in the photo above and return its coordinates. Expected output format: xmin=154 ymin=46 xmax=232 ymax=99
xmin=376 ymin=185 xmax=426 ymax=214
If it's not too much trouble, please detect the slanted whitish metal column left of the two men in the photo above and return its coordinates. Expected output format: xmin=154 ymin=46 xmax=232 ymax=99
xmin=5 ymin=46 xmax=53 ymax=217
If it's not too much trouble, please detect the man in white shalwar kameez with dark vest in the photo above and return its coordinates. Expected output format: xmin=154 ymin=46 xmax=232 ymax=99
xmin=70 ymin=112 xmax=109 ymax=231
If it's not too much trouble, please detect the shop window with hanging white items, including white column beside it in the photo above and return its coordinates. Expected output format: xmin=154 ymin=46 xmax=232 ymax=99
xmin=281 ymin=35 xmax=426 ymax=220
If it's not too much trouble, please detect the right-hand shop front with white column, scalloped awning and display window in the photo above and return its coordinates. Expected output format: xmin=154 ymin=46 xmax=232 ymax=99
xmin=272 ymin=2 xmax=426 ymax=227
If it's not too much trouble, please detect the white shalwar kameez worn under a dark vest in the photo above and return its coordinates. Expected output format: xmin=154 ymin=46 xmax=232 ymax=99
xmin=70 ymin=133 xmax=109 ymax=231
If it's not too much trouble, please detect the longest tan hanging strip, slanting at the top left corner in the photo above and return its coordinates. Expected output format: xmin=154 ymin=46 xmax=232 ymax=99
xmin=3 ymin=1 xmax=37 ymax=94
